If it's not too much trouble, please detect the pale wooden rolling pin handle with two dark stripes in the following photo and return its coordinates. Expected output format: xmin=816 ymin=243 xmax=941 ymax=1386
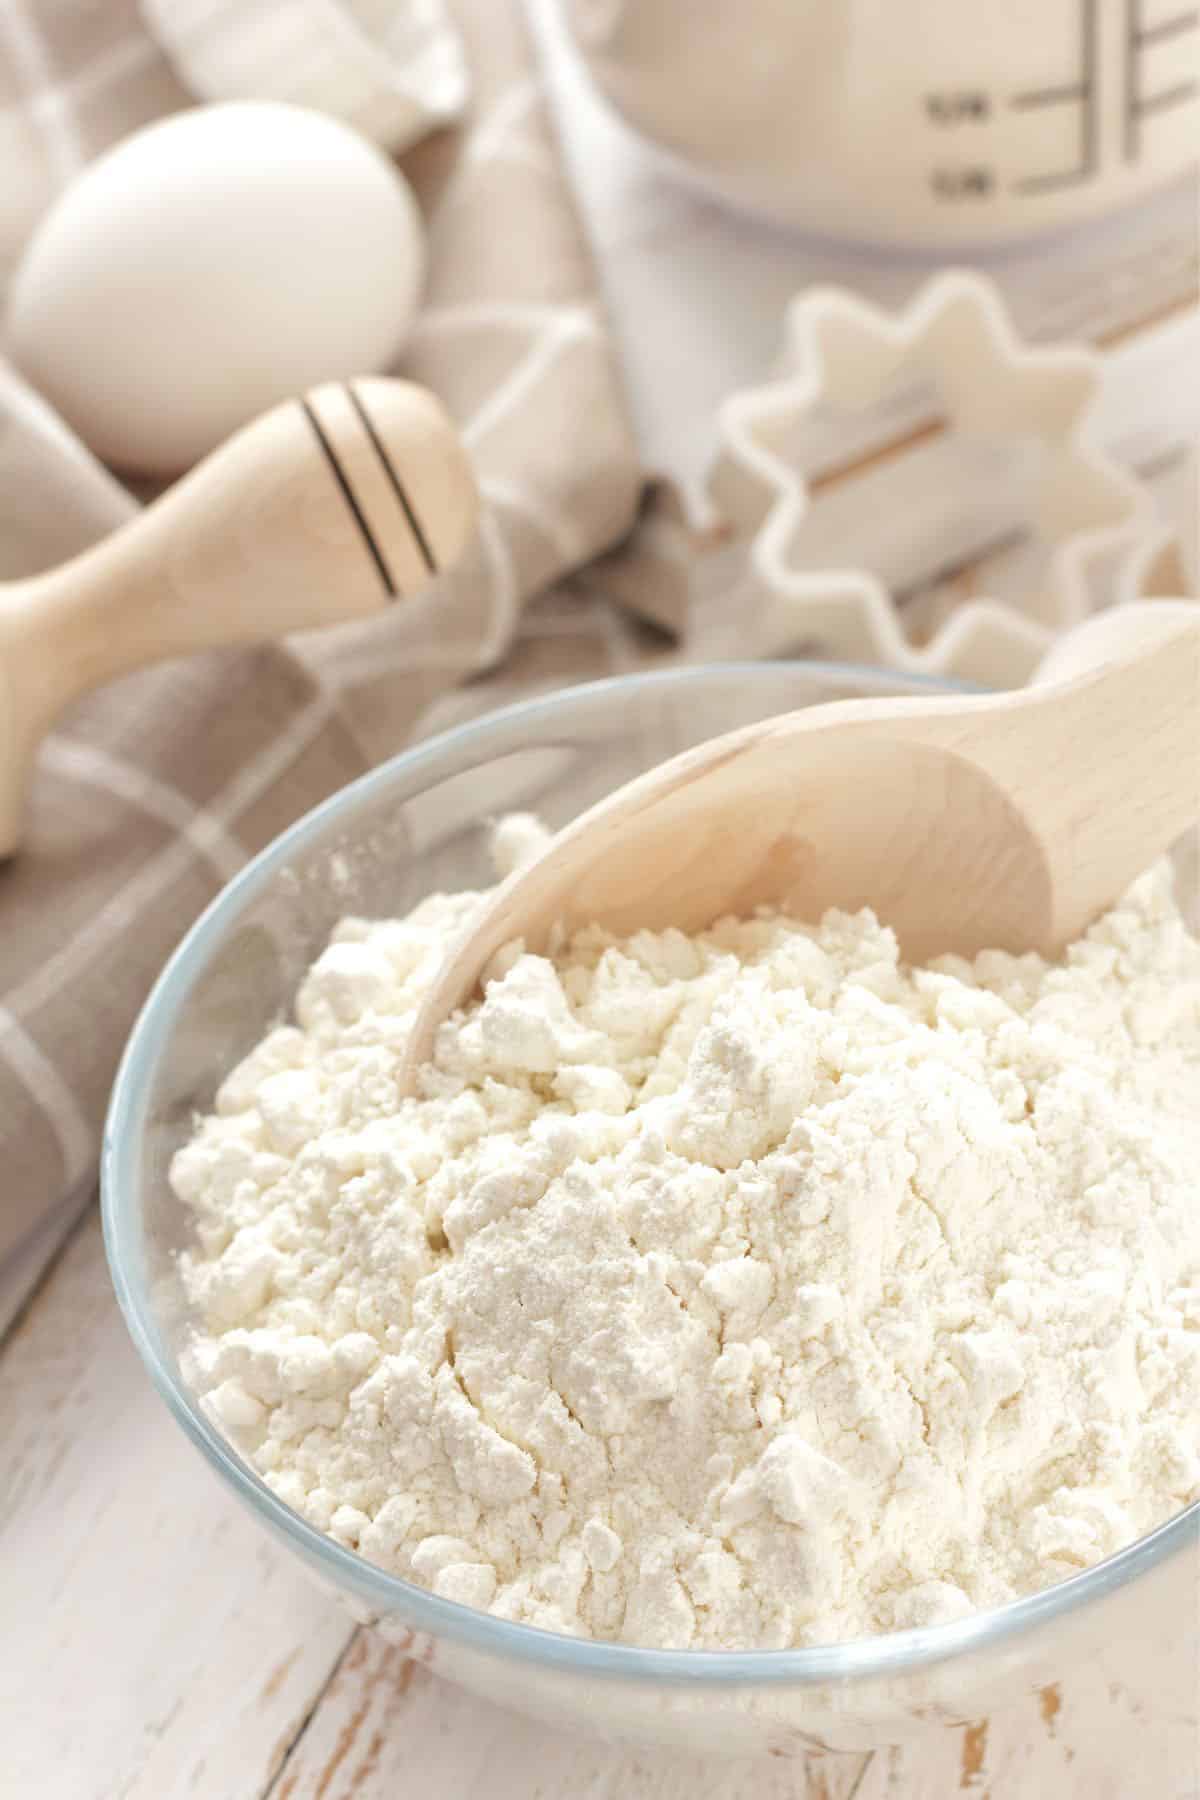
xmin=0 ymin=380 xmax=477 ymax=855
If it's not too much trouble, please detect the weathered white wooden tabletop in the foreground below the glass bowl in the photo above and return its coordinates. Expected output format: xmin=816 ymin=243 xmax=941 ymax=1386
xmin=0 ymin=1180 xmax=1200 ymax=1800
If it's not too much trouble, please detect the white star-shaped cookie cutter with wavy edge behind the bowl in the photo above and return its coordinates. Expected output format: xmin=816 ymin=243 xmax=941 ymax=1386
xmin=711 ymin=270 xmax=1164 ymax=686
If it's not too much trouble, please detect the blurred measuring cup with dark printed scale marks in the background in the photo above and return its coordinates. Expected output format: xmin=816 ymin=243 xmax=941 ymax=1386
xmin=567 ymin=0 xmax=1200 ymax=248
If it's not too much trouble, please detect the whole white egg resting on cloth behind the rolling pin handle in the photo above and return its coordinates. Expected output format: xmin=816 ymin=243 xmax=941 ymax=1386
xmin=7 ymin=101 xmax=425 ymax=475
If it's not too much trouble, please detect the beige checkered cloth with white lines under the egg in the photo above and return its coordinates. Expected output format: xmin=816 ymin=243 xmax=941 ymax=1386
xmin=0 ymin=0 xmax=637 ymax=1258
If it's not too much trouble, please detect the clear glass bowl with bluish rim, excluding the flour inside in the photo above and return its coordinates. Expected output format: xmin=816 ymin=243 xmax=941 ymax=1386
xmin=103 ymin=662 xmax=1200 ymax=1753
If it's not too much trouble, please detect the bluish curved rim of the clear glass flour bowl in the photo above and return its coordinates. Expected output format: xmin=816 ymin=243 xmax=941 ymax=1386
xmin=101 ymin=662 xmax=1200 ymax=1687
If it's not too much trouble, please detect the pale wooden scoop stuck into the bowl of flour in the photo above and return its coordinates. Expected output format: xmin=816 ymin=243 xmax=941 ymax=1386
xmin=403 ymin=601 xmax=1200 ymax=1085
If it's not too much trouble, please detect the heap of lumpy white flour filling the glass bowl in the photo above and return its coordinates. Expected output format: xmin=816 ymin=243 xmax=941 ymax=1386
xmin=173 ymin=821 xmax=1200 ymax=1649
